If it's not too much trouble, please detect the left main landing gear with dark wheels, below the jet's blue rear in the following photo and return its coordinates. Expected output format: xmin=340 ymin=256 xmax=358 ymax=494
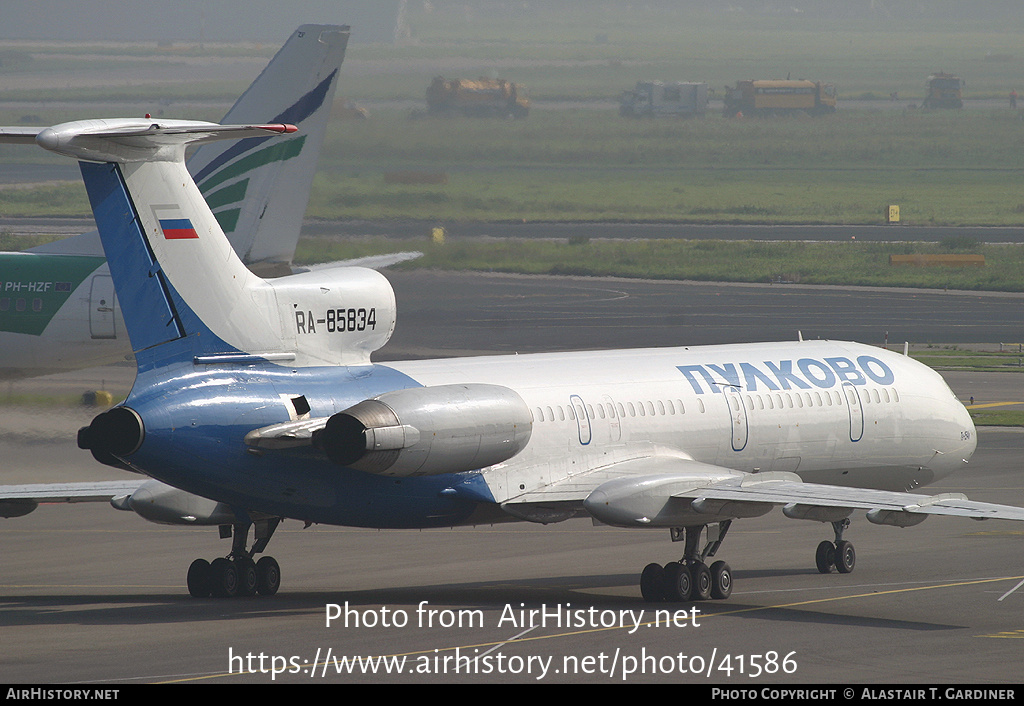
xmin=187 ymin=517 xmax=281 ymax=598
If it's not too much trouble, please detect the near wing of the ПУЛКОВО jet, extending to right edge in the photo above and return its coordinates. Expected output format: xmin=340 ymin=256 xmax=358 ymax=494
xmin=502 ymin=456 xmax=1024 ymax=527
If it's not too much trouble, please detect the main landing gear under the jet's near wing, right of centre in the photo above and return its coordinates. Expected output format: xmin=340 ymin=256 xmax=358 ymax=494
xmin=640 ymin=521 xmax=732 ymax=603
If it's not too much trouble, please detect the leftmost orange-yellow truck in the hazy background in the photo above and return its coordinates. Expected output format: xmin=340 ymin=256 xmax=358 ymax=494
xmin=427 ymin=76 xmax=529 ymax=118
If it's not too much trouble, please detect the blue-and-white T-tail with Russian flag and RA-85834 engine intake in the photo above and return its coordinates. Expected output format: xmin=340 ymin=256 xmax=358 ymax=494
xmin=28 ymin=119 xmax=395 ymax=371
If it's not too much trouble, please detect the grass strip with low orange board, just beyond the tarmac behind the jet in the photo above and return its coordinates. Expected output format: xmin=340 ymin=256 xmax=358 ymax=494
xmin=296 ymin=237 xmax=1024 ymax=291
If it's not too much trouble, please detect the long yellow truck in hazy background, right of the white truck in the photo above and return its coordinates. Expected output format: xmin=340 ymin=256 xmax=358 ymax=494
xmin=722 ymin=79 xmax=836 ymax=117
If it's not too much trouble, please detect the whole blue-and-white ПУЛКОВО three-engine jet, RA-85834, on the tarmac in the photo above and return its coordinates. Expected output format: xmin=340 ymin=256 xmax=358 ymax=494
xmin=0 ymin=119 xmax=1024 ymax=601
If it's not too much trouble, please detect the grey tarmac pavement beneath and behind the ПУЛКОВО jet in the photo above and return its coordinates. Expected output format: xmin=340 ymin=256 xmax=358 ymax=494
xmin=0 ymin=273 xmax=1024 ymax=689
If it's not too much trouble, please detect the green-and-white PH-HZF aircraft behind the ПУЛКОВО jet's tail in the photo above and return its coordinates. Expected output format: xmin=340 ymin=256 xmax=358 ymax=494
xmin=0 ymin=25 xmax=349 ymax=379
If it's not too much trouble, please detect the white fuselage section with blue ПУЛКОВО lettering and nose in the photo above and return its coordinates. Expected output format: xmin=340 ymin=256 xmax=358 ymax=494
xmin=389 ymin=341 xmax=976 ymax=502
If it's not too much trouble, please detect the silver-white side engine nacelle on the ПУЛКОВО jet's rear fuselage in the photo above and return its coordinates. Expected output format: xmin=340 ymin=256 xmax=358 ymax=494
xmin=313 ymin=383 xmax=534 ymax=476
